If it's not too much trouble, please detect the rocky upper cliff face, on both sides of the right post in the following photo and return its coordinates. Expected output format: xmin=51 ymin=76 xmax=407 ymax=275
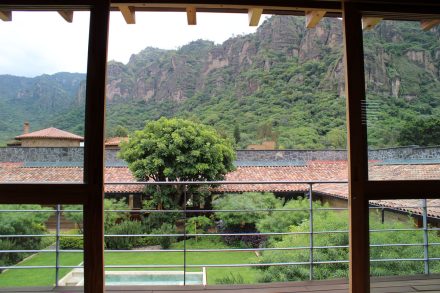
xmin=101 ymin=16 xmax=440 ymax=103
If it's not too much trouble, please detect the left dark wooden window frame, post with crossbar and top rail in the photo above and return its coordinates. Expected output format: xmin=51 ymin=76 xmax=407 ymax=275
xmin=0 ymin=0 xmax=110 ymax=293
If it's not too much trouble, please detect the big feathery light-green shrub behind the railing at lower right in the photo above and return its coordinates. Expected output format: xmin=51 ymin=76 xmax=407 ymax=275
xmin=257 ymin=200 xmax=440 ymax=282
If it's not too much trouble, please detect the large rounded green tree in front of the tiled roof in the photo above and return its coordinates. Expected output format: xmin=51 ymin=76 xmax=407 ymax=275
xmin=119 ymin=118 xmax=235 ymax=208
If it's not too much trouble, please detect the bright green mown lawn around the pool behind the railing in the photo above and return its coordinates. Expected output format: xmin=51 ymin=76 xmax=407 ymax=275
xmin=0 ymin=239 xmax=258 ymax=287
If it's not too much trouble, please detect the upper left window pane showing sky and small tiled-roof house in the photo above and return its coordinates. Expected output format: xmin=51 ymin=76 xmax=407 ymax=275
xmin=0 ymin=11 xmax=89 ymax=182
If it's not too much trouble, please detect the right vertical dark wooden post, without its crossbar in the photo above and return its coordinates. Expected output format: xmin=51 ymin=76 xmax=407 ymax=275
xmin=342 ymin=2 xmax=370 ymax=293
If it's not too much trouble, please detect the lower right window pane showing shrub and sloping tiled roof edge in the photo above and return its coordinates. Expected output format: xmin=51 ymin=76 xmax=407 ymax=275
xmin=370 ymin=199 xmax=440 ymax=282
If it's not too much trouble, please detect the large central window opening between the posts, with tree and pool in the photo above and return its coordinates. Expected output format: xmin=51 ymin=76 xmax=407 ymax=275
xmin=105 ymin=12 xmax=348 ymax=285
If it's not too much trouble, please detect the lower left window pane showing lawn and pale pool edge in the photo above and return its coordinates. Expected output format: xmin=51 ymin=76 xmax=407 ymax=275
xmin=0 ymin=205 xmax=83 ymax=289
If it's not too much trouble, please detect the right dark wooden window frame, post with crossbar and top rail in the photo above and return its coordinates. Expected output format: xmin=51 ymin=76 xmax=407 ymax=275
xmin=343 ymin=1 xmax=440 ymax=293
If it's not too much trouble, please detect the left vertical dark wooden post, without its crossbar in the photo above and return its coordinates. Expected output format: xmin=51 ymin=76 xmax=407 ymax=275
xmin=84 ymin=0 xmax=110 ymax=293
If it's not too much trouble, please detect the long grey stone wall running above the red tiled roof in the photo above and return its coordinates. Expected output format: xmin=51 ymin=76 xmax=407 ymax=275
xmin=0 ymin=146 xmax=440 ymax=165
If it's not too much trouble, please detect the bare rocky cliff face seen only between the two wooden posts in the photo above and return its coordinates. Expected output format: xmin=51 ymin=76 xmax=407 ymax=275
xmin=101 ymin=17 xmax=343 ymax=103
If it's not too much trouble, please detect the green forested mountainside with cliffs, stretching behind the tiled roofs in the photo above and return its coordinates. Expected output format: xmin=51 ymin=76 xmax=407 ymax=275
xmin=0 ymin=16 xmax=440 ymax=149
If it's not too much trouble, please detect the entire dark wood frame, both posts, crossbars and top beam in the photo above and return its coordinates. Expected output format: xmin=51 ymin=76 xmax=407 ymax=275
xmin=0 ymin=0 xmax=440 ymax=293
